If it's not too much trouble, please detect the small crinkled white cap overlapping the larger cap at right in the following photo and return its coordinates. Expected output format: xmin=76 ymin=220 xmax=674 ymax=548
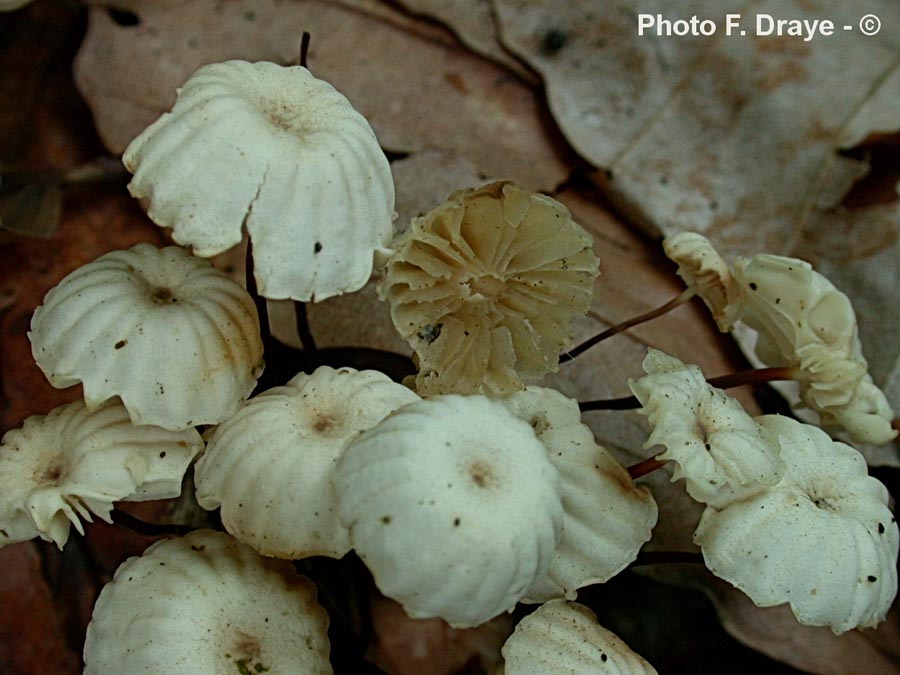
xmin=628 ymin=349 xmax=784 ymax=502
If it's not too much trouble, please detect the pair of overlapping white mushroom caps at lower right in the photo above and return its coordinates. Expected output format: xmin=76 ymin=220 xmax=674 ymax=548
xmin=631 ymin=351 xmax=900 ymax=633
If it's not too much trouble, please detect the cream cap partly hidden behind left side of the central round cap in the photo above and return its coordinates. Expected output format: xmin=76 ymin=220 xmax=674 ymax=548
xmin=194 ymin=366 xmax=419 ymax=559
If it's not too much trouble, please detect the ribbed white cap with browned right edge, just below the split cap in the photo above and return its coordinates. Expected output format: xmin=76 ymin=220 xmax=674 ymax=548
xmin=28 ymin=244 xmax=263 ymax=429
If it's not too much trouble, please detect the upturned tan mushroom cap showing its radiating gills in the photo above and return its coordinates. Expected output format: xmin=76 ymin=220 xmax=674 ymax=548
xmin=381 ymin=182 xmax=599 ymax=396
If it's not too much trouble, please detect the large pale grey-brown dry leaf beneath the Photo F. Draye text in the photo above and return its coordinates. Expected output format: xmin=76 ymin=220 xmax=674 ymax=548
xmin=494 ymin=0 xmax=900 ymax=251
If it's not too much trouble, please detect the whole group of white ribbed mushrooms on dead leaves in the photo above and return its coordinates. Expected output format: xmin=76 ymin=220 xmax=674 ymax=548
xmin=0 ymin=54 xmax=900 ymax=675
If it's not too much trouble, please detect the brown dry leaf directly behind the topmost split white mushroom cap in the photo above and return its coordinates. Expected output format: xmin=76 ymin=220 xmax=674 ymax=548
xmin=75 ymin=0 xmax=567 ymax=189
